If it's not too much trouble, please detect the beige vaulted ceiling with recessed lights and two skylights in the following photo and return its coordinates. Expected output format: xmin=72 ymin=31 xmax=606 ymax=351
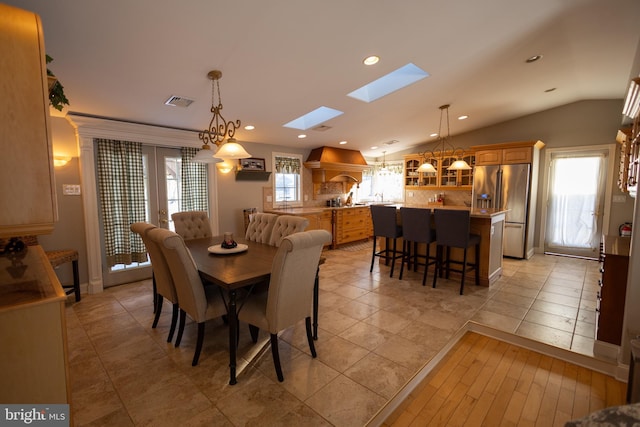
xmin=7 ymin=0 xmax=640 ymax=156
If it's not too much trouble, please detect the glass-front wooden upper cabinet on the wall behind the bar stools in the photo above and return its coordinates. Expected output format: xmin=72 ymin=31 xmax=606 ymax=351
xmin=404 ymin=153 xmax=475 ymax=190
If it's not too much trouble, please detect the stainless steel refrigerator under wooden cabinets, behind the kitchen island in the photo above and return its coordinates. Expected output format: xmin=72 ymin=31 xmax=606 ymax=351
xmin=471 ymin=164 xmax=531 ymax=258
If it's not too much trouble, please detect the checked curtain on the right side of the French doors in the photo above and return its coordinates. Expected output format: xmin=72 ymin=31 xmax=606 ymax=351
xmin=180 ymin=147 xmax=209 ymax=212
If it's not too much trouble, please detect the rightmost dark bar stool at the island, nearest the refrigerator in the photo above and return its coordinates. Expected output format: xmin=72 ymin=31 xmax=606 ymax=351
xmin=433 ymin=209 xmax=480 ymax=295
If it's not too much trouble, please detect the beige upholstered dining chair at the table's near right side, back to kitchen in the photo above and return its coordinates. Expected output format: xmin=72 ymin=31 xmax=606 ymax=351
xmin=238 ymin=230 xmax=331 ymax=382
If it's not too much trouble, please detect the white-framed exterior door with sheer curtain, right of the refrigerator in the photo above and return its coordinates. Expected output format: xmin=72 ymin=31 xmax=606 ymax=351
xmin=543 ymin=146 xmax=615 ymax=259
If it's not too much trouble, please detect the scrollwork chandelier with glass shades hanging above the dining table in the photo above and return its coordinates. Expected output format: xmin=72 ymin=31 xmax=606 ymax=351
xmin=191 ymin=70 xmax=251 ymax=165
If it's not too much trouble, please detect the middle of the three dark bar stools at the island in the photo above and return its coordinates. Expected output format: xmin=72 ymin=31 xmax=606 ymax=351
xmin=399 ymin=207 xmax=437 ymax=287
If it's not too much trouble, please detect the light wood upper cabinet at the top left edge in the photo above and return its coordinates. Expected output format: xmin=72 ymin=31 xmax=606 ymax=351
xmin=0 ymin=4 xmax=57 ymax=237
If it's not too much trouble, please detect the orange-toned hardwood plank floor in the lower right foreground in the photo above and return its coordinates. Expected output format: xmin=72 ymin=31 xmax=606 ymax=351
xmin=383 ymin=332 xmax=626 ymax=427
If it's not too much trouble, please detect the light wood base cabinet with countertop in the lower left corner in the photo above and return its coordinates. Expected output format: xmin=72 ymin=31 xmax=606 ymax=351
xmin=0 ymin=246 xmax=71 ymax=404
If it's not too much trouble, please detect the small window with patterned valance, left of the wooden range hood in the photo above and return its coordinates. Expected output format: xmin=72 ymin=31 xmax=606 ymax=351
xmin=273 ymin=153 xmax=302 ymax=207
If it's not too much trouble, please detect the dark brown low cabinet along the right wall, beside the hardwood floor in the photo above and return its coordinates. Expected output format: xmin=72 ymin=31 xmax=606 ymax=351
xmin=595 ymin=236 xmax=631 ymax=345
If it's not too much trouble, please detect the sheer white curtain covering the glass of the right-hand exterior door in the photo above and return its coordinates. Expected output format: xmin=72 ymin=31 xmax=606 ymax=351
xmin=546 ymin=152 xmax=606 ymax=249
